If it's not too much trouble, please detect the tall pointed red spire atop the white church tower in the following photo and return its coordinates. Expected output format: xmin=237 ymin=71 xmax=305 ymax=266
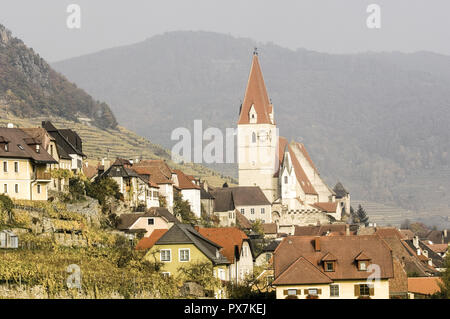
xmin=238 ymin=48 xmax=273 ymax=124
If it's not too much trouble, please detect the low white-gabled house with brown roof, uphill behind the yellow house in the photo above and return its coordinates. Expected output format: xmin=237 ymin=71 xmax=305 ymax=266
xmin=117 ymin=207 xmax=179 ymax=237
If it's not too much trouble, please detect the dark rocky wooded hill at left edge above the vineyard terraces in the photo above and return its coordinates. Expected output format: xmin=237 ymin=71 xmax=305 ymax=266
xmin=0 ymin=24 xmax=117 ymax=128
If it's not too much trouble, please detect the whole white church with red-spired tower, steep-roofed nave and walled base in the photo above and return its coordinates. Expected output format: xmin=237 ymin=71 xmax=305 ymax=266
xmin=237 ymin=50 xmax=350 ymax=227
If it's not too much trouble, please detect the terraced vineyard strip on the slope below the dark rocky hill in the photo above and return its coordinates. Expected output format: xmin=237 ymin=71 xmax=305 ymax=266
xmin=0 ymin=112 xmax=236 ymax=186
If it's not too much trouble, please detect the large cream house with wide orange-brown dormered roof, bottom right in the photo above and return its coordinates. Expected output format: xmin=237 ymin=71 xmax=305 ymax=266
xmin=273 ymin=235 xmax=394 ymax=299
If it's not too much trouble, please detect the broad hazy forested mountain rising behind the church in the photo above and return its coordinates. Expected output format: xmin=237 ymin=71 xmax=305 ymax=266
xmin=53 ymin=32 xmax=450 ymax=220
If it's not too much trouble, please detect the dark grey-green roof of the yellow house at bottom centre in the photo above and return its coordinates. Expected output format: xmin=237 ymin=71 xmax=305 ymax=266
xmin=156 ymin=224 xmax=230 ymax=264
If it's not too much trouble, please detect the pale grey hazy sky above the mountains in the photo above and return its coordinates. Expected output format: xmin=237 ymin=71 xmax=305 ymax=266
xmin=0 ymin=0 xmax=450 ymax=62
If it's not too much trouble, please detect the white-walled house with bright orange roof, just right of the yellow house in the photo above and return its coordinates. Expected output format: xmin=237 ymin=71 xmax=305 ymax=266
xmin=197 ymin=227 xmax=253 ymax=284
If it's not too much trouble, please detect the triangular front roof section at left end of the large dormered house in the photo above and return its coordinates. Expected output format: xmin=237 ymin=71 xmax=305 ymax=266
xmin=273 ymin=257 xmax=333 ymax=285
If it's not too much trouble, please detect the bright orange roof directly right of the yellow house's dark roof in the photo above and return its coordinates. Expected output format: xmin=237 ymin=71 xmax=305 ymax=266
xmin=198 ymin=227 xmax=248 ymax=263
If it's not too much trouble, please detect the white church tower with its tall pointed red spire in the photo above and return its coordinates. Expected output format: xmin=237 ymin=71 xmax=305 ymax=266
xmin=237 ymin=50 xmax=279 ymax=203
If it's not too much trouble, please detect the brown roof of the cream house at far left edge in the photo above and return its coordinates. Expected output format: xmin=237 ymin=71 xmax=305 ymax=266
xmin=0 ymin=127 xmax=58 ymax=164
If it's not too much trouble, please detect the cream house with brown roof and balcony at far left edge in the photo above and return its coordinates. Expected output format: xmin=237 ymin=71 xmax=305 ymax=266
xmin=0 ymin=125 xmax=58 ymax=201
